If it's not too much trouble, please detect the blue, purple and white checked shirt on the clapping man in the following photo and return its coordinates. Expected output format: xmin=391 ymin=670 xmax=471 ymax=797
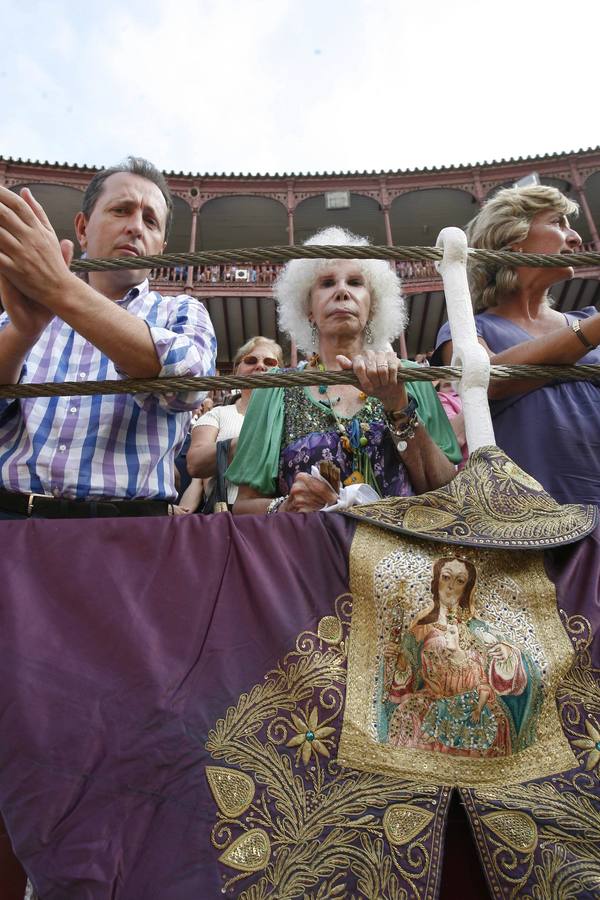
xmin=0 ymin=281 xmax=216 ymax=500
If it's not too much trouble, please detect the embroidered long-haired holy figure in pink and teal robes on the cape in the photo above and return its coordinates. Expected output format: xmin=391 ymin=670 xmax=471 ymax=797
xmin=378 ymin=557 xmax=541 ymax=756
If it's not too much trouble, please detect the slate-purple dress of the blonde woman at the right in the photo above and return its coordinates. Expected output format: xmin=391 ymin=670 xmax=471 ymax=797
xmin=436 ymin=306 xmax=600 ymax=504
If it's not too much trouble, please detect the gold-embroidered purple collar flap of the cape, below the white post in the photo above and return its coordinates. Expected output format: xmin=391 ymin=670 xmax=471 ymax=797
xmin=345 ymin=447 xmax=598 ymax=548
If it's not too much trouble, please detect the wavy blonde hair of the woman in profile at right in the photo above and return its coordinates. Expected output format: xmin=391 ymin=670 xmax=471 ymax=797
xmin=466 ymin=184 xmax=579 ymax=312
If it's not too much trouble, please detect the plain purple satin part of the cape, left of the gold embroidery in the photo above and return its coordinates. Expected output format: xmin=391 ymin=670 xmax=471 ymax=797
xmin=0 ymin=515 xmax=354 ymax=900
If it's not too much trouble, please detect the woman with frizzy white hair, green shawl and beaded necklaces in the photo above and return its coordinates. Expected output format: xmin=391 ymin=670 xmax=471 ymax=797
xmin=227 ymin=228 xmax=461 ymax=514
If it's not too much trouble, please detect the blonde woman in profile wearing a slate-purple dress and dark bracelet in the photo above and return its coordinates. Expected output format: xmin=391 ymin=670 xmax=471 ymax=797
xmin=436 ymin=185 xmax=600 ymax=504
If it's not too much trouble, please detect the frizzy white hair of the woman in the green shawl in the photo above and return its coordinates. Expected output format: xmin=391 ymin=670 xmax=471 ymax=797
xmin=273 ymin=226 xmax=406 ymax=353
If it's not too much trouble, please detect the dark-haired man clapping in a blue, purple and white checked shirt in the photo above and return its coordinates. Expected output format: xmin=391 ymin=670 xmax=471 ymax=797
xmin=0 ymin=157 xmax=216 ymax=518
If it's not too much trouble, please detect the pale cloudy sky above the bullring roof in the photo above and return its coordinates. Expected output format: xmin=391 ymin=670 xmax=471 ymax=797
xmin=0 ymin=0 xmax=600 ymax=173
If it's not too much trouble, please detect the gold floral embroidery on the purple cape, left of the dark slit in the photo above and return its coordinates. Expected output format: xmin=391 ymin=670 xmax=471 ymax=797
xmin=206 ymin=595 xmax=450 ymax=900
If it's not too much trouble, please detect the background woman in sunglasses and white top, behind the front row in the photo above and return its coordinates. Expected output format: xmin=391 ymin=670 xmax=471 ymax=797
xmin=181 ymin=335 xmax=283 ymax=512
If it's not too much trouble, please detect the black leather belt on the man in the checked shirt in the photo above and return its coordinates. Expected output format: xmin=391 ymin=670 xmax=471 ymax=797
xmin=0 ymin=490 xmax=172 ymax=519
